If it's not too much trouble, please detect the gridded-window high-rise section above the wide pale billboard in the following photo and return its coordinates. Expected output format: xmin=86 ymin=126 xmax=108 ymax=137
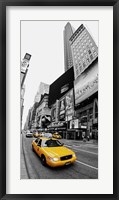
xmin=69 ymin=24 xmax=98 ymax=79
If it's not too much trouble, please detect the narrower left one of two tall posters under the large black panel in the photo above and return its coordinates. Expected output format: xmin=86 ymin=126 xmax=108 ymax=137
xmin=59 ymin=98 xmax=65 ymax=121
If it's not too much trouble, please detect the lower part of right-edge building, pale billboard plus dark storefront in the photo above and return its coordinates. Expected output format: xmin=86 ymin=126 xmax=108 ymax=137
xmin=74 ymin=60 xmax=98 ymax=139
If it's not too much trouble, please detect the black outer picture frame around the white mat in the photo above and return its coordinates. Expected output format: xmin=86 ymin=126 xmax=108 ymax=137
xmin=0 ymin=0 xmax=119 ymax=200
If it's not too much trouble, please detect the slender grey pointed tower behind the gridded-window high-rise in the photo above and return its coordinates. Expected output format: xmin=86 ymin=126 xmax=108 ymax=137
xmin=64 ymin=22 xmax=73 ymax=72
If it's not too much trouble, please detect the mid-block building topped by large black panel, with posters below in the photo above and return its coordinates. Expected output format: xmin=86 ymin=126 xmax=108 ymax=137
xmin=48 ymin=67 xmax=74 ymax=138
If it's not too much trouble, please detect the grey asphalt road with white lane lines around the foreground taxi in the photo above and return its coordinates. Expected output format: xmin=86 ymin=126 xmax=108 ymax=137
xmin=21 ymin=135 xmax=98 ymax=179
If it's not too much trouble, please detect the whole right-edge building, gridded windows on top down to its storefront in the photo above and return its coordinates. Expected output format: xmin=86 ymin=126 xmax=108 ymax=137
xmin=70 ymin=24 xmax=98 ymax=139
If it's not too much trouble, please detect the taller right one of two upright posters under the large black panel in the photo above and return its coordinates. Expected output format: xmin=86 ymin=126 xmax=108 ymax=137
xmin=65 ymin=89 xmax=74 ymax=121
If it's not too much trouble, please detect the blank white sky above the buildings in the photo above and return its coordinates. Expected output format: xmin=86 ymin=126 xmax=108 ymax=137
xmin=20 ymin=21 xmax=98 ymax=127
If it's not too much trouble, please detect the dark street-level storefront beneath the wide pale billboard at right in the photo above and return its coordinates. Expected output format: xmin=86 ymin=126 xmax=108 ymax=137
xmin=76 ymin=92 xmax=98 ymax=139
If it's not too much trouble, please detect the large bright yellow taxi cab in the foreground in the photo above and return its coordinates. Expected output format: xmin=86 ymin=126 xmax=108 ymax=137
xmin=32 ymin=137 xmax=76 ymax=167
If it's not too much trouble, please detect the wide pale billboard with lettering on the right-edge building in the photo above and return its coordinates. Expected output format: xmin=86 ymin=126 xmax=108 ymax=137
xmin=74 ymin=63 xmax=98 ymax=105
